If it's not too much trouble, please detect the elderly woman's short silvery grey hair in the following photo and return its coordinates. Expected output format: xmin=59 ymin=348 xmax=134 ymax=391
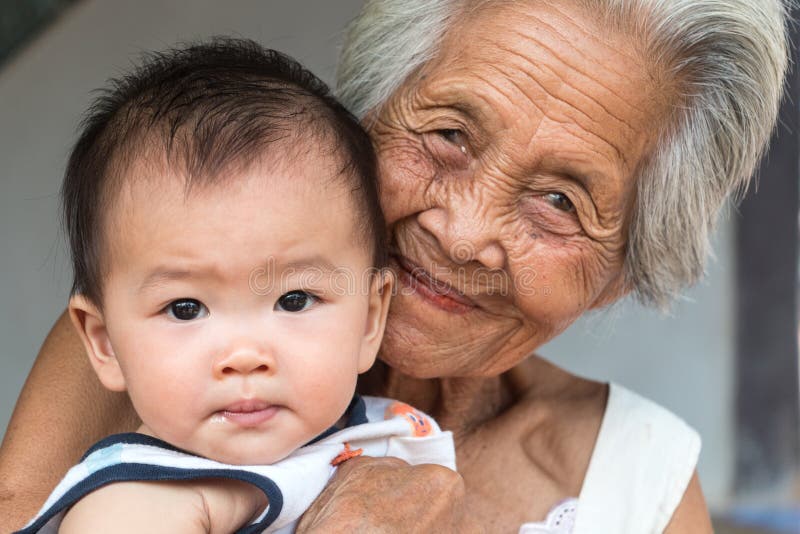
xmin=337 ymin=0 xmax=789 ymax=309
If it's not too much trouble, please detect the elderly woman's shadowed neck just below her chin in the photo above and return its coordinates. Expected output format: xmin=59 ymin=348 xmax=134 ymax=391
xmin=359 ymin=361 xmax=515 ymax=442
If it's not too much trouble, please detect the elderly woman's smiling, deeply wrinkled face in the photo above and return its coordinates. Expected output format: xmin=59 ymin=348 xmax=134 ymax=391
xmin=371 ymin=4 xmax=667 ymax=377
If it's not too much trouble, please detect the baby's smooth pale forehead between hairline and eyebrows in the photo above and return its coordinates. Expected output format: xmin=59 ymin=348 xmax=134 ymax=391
xmin=103 ymin=143 xmax=371 ymax=262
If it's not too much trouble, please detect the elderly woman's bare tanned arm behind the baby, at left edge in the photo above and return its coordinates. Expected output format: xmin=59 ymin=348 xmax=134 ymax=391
xmin=0 ymin=313 xmax=139 ymax=532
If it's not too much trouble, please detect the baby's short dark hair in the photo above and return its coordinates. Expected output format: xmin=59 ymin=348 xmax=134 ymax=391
xmin=61 ymin=38 xmax=387 ymax=306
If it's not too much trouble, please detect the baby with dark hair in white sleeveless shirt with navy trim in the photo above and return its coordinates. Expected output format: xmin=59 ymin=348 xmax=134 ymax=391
xmin=21 ymin=39 xmax=455 ymax=532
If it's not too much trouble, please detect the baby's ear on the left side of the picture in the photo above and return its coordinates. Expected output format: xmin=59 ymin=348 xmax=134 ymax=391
xmin=69 ymin=295 xmax=125 ymax=391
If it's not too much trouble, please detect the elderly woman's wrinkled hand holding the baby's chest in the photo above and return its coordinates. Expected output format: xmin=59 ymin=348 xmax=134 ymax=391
xmin=296 ymin=456 xmax=479 ymax=534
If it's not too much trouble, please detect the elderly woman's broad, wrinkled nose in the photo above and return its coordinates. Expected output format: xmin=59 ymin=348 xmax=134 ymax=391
xmin=417 ymin=202 xmax=506 ymax=269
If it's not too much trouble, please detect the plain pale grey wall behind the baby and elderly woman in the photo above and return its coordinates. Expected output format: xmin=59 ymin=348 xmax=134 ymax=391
xmin=0 ymin=0 xmax=734 ymax=510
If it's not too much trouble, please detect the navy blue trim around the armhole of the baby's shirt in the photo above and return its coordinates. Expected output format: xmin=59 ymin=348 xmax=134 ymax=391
xmin=16 ymin=464 xmax=283 ymax=534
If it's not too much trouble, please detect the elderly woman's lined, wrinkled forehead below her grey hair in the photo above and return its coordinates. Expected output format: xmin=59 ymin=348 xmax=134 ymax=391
xmin=415 ymin=3 xmax=667 ymax=187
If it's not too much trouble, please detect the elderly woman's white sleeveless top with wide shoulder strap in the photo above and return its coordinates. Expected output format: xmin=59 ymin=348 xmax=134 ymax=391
xmin=519 ymin=384 xmax=700 ymax=534
